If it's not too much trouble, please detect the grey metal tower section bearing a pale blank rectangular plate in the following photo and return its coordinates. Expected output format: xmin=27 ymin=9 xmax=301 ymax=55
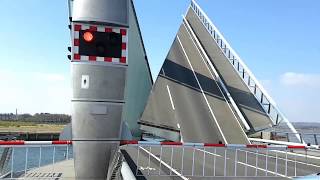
xmin=72 ymin=102 xmax=123 ymax=140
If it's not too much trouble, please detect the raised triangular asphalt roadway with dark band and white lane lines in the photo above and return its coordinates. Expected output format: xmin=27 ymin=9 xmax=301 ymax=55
xmin=141 ymin=19 xmax=249 ymax=144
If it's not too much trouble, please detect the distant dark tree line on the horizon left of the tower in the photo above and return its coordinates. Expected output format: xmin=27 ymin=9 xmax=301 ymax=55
xmin=0 ymin=113 xmax=71 ymax=124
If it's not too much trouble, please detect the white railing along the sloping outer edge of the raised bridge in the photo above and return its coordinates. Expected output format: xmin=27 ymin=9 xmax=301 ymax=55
xmin=190 ymin=0 xmax=301 ymax=141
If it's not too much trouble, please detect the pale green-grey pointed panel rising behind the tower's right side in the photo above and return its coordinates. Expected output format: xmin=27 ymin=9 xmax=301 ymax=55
xmin=122 ymin=2 xmax=152 ymax=137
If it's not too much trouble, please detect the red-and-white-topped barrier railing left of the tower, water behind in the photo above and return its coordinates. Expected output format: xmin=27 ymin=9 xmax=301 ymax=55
xmin=0 ymin=141 xmax=73 ymax=179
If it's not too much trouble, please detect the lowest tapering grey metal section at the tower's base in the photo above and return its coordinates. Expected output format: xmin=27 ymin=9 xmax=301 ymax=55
xmin=73 ymin=142 xmax=119 ymax=179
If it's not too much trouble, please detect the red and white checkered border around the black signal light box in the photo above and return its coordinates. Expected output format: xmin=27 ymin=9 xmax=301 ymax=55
xmin=72 ymin=23 xmax=127 ymax=64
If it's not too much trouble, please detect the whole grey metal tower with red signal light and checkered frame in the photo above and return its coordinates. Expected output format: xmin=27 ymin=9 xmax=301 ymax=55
xmin=71 ymin=0 xmax=129 ymax=179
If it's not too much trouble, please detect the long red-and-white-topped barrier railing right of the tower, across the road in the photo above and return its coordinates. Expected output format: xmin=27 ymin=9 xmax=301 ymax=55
xmin=122 ymin=141 xmax=320 ymax=179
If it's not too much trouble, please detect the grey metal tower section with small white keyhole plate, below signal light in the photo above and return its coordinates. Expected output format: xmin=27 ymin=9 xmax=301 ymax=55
xmin=72 ymin=63 xmax=126 ymax=101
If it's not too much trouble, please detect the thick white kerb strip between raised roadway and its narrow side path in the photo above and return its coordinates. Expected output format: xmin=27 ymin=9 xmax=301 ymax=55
xmin=183 ymin=16 xmax=250 ymax=132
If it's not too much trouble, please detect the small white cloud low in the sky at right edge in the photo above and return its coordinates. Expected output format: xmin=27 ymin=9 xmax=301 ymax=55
xmin=280 ymin=72 xmax=320 ymax=88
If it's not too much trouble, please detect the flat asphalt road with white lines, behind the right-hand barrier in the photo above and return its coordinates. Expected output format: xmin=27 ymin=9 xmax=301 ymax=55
xmin=121 ymin=146 xmax=320 ymax=179
